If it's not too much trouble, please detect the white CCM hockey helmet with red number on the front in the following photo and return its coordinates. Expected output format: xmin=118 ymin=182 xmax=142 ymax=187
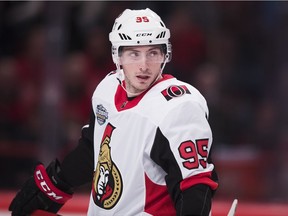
xmin=109 ymin=8 xmax=171 ymax=65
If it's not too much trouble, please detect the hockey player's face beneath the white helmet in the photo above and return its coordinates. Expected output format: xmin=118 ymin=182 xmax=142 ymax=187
xmin=120 ymin=45 xmax=164 ymax=96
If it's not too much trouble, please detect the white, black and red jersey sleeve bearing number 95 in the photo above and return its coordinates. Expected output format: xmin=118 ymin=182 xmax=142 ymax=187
xmin=151 ymin=101 xmax=218 ymax=212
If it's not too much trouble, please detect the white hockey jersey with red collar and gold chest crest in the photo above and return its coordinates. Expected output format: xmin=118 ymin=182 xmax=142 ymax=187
xmin=88 ymin=73 xmax=217 ymax=216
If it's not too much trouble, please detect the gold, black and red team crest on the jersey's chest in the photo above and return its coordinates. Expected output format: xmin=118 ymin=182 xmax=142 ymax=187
xmin=92 ymin=123 xmax=123 ymax=209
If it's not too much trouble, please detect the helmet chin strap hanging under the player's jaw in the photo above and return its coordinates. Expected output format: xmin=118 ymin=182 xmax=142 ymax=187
xmin=116 ymin=54 xmax=169 ymax=97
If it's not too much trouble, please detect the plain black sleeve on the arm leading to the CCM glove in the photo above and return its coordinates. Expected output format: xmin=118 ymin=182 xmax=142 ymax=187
xmin=59 ymin=109 xmax=95 ymax=187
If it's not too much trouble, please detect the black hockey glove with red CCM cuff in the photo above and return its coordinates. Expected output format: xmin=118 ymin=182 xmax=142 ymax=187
xmin=9 ymin=160 xmax=73 ymax=216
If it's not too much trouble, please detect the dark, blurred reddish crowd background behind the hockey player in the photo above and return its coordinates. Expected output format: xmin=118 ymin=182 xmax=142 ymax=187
xmin=0 ymin=1 xmax=288 ymax=208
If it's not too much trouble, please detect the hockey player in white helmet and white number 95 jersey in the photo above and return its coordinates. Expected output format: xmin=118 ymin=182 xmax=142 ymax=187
xmin=9 ymin=8 xmax=218 ymax=216
